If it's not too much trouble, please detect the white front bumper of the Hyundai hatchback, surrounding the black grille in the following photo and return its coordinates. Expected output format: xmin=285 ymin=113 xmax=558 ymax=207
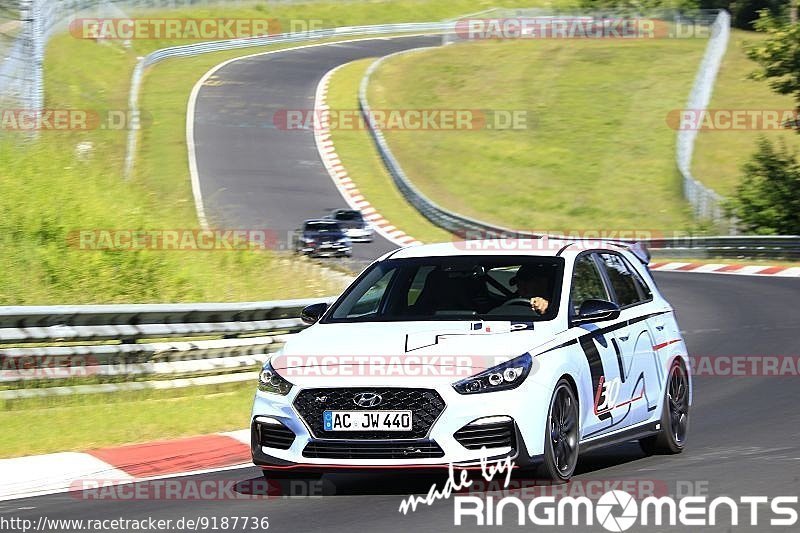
xmin=251 ymin=385 xmax=544 ymax=471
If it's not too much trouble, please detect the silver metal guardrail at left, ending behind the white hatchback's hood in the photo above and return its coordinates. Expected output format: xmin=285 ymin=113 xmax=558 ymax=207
xmin=0 ymin=298 xmax=331 ymax=388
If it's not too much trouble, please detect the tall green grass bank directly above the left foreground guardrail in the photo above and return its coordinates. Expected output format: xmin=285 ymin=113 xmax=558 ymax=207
xmin=0 ymin=132 xmax=341 ymax=305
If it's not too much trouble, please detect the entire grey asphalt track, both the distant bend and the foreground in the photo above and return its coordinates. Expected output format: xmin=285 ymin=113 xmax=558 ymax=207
xmin=7 ymin=35 xmax=800 ymax=532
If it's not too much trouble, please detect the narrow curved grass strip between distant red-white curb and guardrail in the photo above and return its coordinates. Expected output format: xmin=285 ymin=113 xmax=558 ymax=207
xmin=327 ymin=59 xmax=452 ymax=242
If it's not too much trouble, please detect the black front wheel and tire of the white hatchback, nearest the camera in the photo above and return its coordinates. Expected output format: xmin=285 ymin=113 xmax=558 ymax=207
xmin=539 ymin=379 xmax=579 ymax=483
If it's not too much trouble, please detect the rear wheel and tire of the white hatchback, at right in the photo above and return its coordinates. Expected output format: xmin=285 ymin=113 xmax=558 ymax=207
xmin=639 ymin=359 xmax=689 ymax=455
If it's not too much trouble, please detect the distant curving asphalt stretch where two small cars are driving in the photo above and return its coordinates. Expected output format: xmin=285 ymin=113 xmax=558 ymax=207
xmin=195 ymin=33 xmax=441 ymax=263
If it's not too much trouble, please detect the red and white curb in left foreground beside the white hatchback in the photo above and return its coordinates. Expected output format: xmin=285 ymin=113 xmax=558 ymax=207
xmin=0 ymin=429 xmax=252 ymax=501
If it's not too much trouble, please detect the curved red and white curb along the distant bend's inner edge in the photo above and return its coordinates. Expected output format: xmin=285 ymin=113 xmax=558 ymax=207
xmin=314 ymin=65 xmax=421 ymax=246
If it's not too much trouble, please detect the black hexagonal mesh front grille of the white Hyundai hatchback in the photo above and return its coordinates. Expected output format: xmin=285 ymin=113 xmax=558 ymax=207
xmin=294 ymin=387 xmax=445 ymax=440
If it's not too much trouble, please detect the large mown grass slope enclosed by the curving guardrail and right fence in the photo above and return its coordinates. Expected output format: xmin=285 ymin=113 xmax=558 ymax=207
xmin=365 ymin=39 xmax=706 ymax=232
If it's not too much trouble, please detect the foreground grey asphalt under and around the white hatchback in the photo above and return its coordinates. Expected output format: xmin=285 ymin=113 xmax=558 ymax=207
xmin=10 ymin=273 xmax=800 ymax=532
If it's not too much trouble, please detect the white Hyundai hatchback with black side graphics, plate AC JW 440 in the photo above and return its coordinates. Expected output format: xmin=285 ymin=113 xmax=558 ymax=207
xmin=251 ymin=239 xmax=692 ymax=481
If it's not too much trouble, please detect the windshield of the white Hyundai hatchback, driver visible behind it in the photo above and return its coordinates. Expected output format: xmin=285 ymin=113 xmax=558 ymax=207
xmin=323 ymin=256 xmax=564 ymax=322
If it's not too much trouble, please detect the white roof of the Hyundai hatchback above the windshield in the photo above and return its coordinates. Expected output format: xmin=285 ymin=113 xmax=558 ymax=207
xmin=390 ymin=237 xmax=630 ymax=259
